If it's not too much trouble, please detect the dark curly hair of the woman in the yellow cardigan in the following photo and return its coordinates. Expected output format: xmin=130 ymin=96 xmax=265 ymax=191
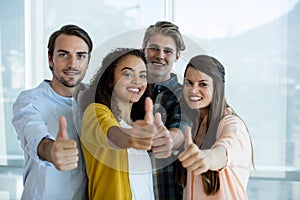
xmin=80 ymin=48 xmax=146 ymax=120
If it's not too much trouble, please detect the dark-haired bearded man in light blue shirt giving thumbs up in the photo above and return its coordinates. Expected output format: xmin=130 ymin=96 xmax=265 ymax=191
xmin=12 ymin=25 xmax=93 ymax=200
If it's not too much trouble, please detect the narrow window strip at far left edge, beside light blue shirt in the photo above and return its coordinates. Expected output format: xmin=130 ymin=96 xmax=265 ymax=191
xmin=0 ymin=0 xmax=25 ymax=199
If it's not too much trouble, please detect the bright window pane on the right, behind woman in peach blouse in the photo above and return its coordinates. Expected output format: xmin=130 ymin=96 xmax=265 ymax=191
xmin=174 ymin=0 xmax=300 ymax=199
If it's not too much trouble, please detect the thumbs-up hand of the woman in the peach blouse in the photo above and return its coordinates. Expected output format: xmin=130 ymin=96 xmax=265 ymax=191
xmin=178 ymin=126 xmax=210 ymax=175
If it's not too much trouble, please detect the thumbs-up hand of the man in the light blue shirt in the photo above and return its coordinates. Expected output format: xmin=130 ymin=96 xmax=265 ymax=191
xmin=51 ymin=116 xmax=79 ymax=171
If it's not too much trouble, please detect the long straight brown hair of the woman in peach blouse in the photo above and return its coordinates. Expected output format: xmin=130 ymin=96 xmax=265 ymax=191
xmin=183 ymin=55 xmax=253 ymax=195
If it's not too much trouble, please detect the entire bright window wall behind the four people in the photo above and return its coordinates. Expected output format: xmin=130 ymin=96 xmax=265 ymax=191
xmin=0 ymin=0 xmax=300 ymax=199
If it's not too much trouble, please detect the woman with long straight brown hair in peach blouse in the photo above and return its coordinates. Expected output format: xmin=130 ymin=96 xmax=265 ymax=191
xmin=178 ymin=55 xmax=253 ymax=200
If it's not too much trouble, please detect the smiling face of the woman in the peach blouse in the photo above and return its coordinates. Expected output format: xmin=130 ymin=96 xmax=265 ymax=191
xmin=183 ymin=67 xmax=214 ymax=109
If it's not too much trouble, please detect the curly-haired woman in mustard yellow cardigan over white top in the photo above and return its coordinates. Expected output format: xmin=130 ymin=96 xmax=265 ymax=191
xmin=81 ymin=48 xmax=161 ymax=200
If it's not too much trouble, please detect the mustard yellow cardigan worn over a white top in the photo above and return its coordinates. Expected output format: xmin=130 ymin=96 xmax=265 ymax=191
xmin=81 ymin=103 xmax=132 ymax=200
